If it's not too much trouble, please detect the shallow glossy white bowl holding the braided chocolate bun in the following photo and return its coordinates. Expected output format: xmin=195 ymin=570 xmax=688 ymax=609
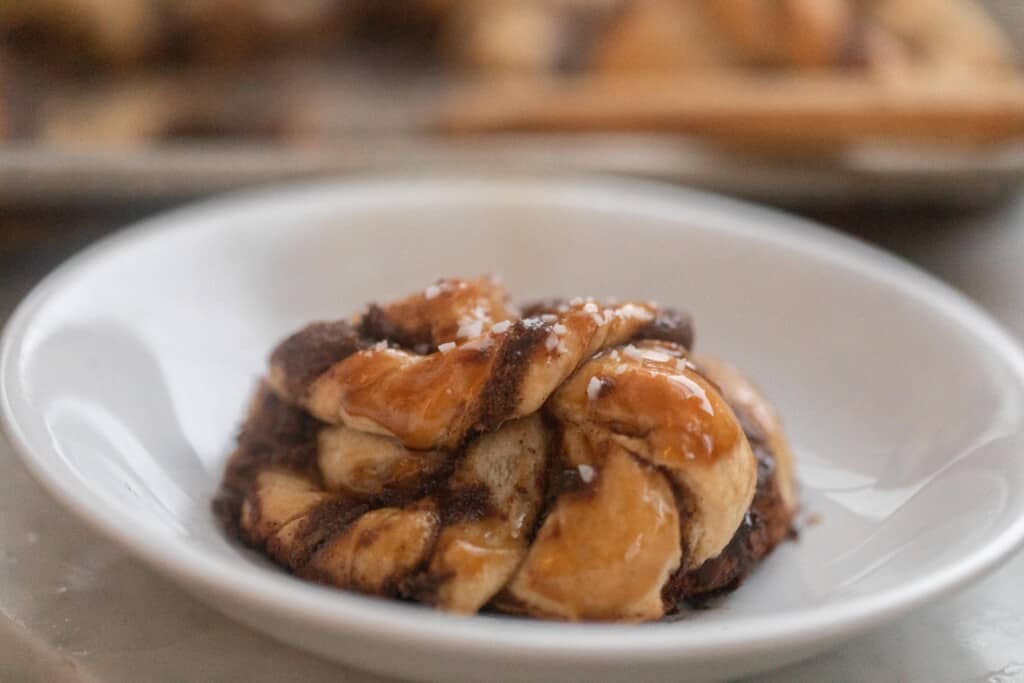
xmin=0 ymin=179 xmax=1024 ymax=681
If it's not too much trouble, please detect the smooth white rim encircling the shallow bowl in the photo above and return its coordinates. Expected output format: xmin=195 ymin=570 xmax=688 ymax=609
xmin=0 ymin=175 xmax=1024 ymax=660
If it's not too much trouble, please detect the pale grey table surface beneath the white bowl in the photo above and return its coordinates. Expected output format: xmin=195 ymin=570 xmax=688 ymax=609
xmin=0 ymin=197 xmax=1024 ymax=683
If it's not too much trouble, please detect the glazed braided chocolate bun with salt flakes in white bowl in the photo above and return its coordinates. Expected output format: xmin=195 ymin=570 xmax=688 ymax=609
xmin=215 ymin=279 xmax=797 ymax=622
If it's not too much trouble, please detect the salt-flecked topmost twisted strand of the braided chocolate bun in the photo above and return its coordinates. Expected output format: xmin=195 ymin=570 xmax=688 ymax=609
xmin=270 ymin=286 xmax=689 ymax=451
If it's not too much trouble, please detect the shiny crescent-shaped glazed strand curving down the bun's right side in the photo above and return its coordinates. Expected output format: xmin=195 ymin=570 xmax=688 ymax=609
xmin=549 ymin=341 xmax=757 ymax=567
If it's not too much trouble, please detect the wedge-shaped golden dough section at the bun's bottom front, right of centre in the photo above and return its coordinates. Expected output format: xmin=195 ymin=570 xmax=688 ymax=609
xmin=507 ymin=441 xmax=682 ymax=622
